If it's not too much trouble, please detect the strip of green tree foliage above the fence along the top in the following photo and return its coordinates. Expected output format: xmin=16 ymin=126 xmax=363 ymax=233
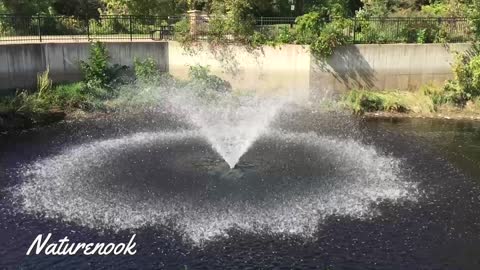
xmin=0 ymin=0 xmax=480 ymax=17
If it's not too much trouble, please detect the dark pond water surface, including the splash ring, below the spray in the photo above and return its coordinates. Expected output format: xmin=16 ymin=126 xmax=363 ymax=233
xmin=0 ymin=112 xmax=480 ymax=269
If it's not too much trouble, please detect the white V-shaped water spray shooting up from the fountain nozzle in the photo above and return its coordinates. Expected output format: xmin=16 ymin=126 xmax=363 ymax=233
xmin=169 ymin=90 xmax=289 ymax=168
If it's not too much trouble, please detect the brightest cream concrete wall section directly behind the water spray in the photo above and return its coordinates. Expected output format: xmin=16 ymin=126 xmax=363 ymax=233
xmin=168 ymin=42 xmax=311 ymax=97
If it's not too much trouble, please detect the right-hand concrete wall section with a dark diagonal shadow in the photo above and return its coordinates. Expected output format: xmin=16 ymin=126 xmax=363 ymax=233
xmin=310 ymin=44 xmax=470 ymax=94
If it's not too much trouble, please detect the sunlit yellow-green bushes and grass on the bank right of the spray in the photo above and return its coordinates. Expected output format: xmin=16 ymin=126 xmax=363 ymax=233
xmin=342 ymin=44 xmax=480 ymax=119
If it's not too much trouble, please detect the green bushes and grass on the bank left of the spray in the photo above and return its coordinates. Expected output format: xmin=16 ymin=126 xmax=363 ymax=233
xmin=0 ymin=42 xmax=231 ymax=132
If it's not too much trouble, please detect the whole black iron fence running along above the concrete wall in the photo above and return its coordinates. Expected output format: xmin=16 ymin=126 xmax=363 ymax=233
xmin=0 ymin=15 xmax=472 ymax=43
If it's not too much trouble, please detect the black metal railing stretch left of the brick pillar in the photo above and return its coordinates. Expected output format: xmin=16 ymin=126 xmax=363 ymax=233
xmin=0 ymin=15 xmax=175 ymax=43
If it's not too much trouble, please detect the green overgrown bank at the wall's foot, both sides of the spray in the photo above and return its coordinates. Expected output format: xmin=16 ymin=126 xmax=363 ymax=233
xmin=4 ymin=42 xmax=480 ymax=131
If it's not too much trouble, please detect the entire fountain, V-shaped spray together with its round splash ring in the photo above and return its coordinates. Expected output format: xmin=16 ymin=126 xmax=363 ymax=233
xmin=9 ymin=87 xmax=416 ymax=244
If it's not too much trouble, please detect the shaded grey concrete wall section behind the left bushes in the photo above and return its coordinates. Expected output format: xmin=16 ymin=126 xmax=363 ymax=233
xmin=0 ymin=42 xmax=168 ymax=93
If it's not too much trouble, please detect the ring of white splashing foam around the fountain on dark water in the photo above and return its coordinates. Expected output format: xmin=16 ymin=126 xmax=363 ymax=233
xmin=9 ymin=131 xmax=416 ymax=244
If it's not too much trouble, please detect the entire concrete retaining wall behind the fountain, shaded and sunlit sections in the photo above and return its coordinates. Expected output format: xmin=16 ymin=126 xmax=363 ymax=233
xmin=0 ymin=41 xmax=469 ymax=97
